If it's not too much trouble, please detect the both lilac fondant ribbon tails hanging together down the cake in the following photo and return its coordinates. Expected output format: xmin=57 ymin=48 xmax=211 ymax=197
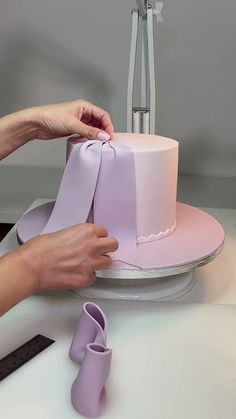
xmin=41 ymin=141 xmax=140 ymax=267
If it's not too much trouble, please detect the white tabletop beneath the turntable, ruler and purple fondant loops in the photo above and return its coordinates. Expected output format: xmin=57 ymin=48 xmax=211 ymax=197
xmin=0 ymin=201 xmax=236 ymax=419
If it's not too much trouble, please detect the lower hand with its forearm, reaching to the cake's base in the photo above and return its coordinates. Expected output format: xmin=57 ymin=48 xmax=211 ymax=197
xmin=0 ymin=224 xmax=118 ymax=316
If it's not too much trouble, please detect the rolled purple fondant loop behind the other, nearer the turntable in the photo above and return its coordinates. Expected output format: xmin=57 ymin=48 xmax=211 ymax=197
xmin=69 ymin=302 xmax=107 ymax=364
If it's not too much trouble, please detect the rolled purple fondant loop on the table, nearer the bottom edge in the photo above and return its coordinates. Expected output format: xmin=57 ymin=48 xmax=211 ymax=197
xmin=71 ymin=343 xmax=112 ymax=418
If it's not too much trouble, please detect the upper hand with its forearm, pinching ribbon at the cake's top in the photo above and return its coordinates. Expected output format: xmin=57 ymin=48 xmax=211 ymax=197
xmin=0 ymin=100 xmax=114 ymax=160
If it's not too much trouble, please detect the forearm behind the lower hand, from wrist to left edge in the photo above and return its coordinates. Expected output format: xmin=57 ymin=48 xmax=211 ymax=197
xmin=0 ymin=251 xmax=37 ymax=317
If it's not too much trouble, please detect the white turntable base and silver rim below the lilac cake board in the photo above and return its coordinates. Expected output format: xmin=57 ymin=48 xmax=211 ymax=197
xmin=72 ymin=244 xmax=223 ymax=301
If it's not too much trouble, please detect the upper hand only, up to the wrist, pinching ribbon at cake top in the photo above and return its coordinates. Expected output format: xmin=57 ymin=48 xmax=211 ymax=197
xmin=31 ymin=100 xmax=114 ymax=141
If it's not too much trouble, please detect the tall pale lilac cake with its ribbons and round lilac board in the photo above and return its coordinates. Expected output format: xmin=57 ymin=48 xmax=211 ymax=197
xmin=17 ymin=133 xmax=224 ymax=270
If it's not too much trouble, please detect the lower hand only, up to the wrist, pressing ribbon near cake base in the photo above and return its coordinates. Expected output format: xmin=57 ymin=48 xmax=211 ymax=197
xmin=17 ymin=224 xmax=118 ymax=291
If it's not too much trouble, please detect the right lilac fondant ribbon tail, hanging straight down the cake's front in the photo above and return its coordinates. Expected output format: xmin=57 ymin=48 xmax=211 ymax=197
xmin=94 ymin=143 xmax=140 ymax=267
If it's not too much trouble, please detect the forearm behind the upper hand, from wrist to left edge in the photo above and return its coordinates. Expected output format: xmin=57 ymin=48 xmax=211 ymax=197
xmin=0 ymin=108 xmax=37 ymax=160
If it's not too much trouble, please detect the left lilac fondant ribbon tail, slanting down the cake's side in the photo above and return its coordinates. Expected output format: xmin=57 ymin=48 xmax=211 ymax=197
xmin=41 ymin=141 xmax=102 ymax=234
